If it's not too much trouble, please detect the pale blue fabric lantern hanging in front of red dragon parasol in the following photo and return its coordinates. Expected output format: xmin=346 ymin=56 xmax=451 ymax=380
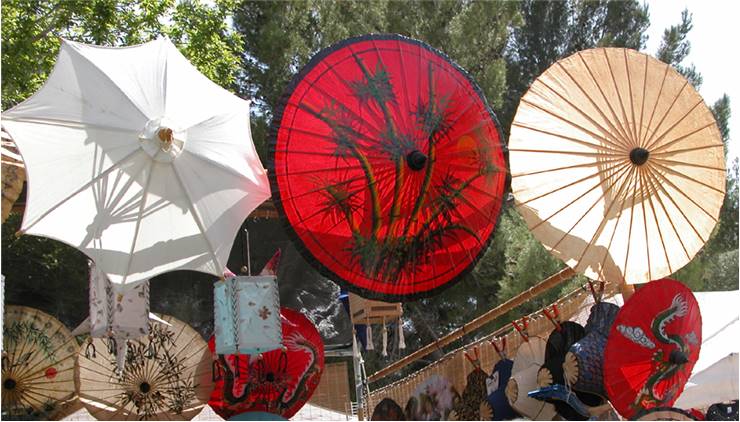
xmin=213 ymin=276 xmax=283 ymax=355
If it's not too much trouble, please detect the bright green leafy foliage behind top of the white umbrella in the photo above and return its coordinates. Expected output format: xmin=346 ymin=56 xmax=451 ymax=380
xmin=2 ymin=0 xmax=242 ymax=109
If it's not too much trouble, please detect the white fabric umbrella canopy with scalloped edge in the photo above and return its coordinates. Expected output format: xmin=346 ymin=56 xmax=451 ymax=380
xmin=3 ymin=39 xmax=270 ymax=283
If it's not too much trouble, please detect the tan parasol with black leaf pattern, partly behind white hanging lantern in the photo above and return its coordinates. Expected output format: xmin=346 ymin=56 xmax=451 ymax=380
xmin=77 ymin=316 xmax=213 ymax=420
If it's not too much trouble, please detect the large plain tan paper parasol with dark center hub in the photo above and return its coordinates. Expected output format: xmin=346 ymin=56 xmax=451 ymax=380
xmin=509 ymin=48 xmax=725 ymax=284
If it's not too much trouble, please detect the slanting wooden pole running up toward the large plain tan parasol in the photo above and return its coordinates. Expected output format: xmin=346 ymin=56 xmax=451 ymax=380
xmin=367 ymin=267 xmax=575 ymax=382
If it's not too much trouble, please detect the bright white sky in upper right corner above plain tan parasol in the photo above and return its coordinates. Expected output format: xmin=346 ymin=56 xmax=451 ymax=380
xmin=645 ymin=0 xmax=740 ymax=162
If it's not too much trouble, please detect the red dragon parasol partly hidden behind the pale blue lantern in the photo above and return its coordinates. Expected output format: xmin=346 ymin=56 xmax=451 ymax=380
xmin=208 ymin=308 xmax=324 ymax=419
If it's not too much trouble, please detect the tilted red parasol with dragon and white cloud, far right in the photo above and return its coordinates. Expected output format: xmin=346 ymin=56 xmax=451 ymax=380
xmin=604 ymin=278 xmax=701 ymax=418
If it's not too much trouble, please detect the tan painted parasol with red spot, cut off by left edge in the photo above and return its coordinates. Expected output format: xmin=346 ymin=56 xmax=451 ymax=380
xmin=2 ymin=305 xmax=79 ymax=420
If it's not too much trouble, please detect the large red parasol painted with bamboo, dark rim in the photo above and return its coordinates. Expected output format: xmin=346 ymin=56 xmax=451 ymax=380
xmin=269 ymin=34 xmax=507 ymax=302
